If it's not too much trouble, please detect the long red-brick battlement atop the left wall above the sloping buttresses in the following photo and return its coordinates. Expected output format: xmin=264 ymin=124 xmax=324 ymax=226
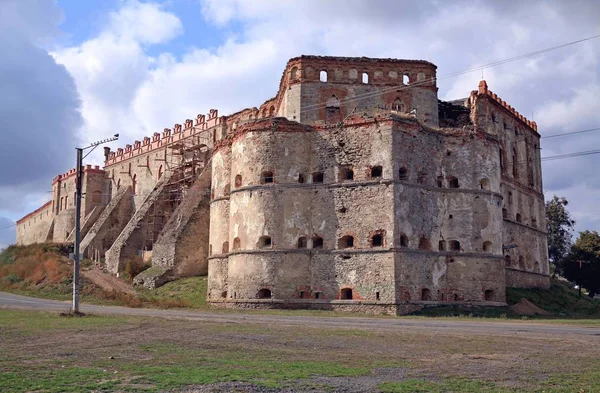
xmin=104 ymin=109 xmax=224 ymax=167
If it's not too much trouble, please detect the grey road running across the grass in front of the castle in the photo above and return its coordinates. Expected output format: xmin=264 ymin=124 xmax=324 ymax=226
xmin=0 ymin=292 xmax=600 ymax=336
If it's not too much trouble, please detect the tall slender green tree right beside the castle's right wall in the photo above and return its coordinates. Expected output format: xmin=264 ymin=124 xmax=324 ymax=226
xmin=546 ymin=195 xmax=575 ymax=276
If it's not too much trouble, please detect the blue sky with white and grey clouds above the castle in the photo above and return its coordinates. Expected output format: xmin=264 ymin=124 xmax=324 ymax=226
xmin=0 ymin=0 xmax=600 ymax=247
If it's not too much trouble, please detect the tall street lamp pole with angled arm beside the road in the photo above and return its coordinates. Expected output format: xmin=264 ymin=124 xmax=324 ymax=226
xmin=71 ymin=134 xmax=119 ymax=314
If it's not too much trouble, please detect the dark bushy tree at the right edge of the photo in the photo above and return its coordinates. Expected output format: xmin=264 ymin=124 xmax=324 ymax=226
xmin=563 ymin=231 xmax=600 ymax=297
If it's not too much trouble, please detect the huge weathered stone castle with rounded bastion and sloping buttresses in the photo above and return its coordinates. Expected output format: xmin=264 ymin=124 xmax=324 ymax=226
xmin=17 ymin=56 xmax=549 ymax=314
